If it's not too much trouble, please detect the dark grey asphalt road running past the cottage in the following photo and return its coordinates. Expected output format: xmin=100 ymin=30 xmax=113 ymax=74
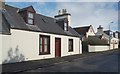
xmin=19 ymin=51 xmax=120 ymax=72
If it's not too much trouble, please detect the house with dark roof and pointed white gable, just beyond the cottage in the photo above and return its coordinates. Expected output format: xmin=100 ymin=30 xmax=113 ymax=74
xmin=74 ymin=25 xmax=95 ymax=41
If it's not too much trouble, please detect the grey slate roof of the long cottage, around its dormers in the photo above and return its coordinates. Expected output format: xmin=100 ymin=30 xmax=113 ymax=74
xmin=0 ymin=5 xmax=80 ymax=37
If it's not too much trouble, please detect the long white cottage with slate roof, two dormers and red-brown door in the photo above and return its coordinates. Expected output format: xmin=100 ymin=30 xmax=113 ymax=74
xmin=0 ymin=5 xmax=82 ymax=64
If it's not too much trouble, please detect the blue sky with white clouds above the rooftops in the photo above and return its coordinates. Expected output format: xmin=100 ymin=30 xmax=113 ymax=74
xmin=6 ymin=0 xmax=120 ymax=32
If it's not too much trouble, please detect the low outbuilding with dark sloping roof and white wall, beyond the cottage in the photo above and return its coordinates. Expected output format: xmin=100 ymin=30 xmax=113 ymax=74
xmin=86 ymin=36 xmax=109 ymax=52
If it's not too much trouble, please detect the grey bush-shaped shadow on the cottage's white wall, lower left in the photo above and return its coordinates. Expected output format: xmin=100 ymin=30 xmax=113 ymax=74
xmin=3 ymin=45 xmax=25 ymax=64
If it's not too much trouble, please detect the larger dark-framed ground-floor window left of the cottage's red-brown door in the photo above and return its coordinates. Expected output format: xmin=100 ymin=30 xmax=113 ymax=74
xmin=39 ymin=35 xmax=50 ymax=55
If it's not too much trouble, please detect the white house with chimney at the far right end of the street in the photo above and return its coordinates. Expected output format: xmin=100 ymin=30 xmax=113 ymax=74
xmin=96 ymin=25 xmax=118 ymax=49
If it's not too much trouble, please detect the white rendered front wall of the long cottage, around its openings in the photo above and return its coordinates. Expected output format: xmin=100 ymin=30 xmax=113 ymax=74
xmin=0 ymin=29 xmax=82 ymax=64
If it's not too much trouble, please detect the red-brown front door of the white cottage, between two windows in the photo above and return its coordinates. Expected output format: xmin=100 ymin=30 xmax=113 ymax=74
xmin=55 ymin=38 xmax=61 ymax=57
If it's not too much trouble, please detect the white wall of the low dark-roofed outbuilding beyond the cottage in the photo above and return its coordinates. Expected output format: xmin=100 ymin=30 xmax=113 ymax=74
xmin=88 ymin=45 xmax=109 ymax=52
